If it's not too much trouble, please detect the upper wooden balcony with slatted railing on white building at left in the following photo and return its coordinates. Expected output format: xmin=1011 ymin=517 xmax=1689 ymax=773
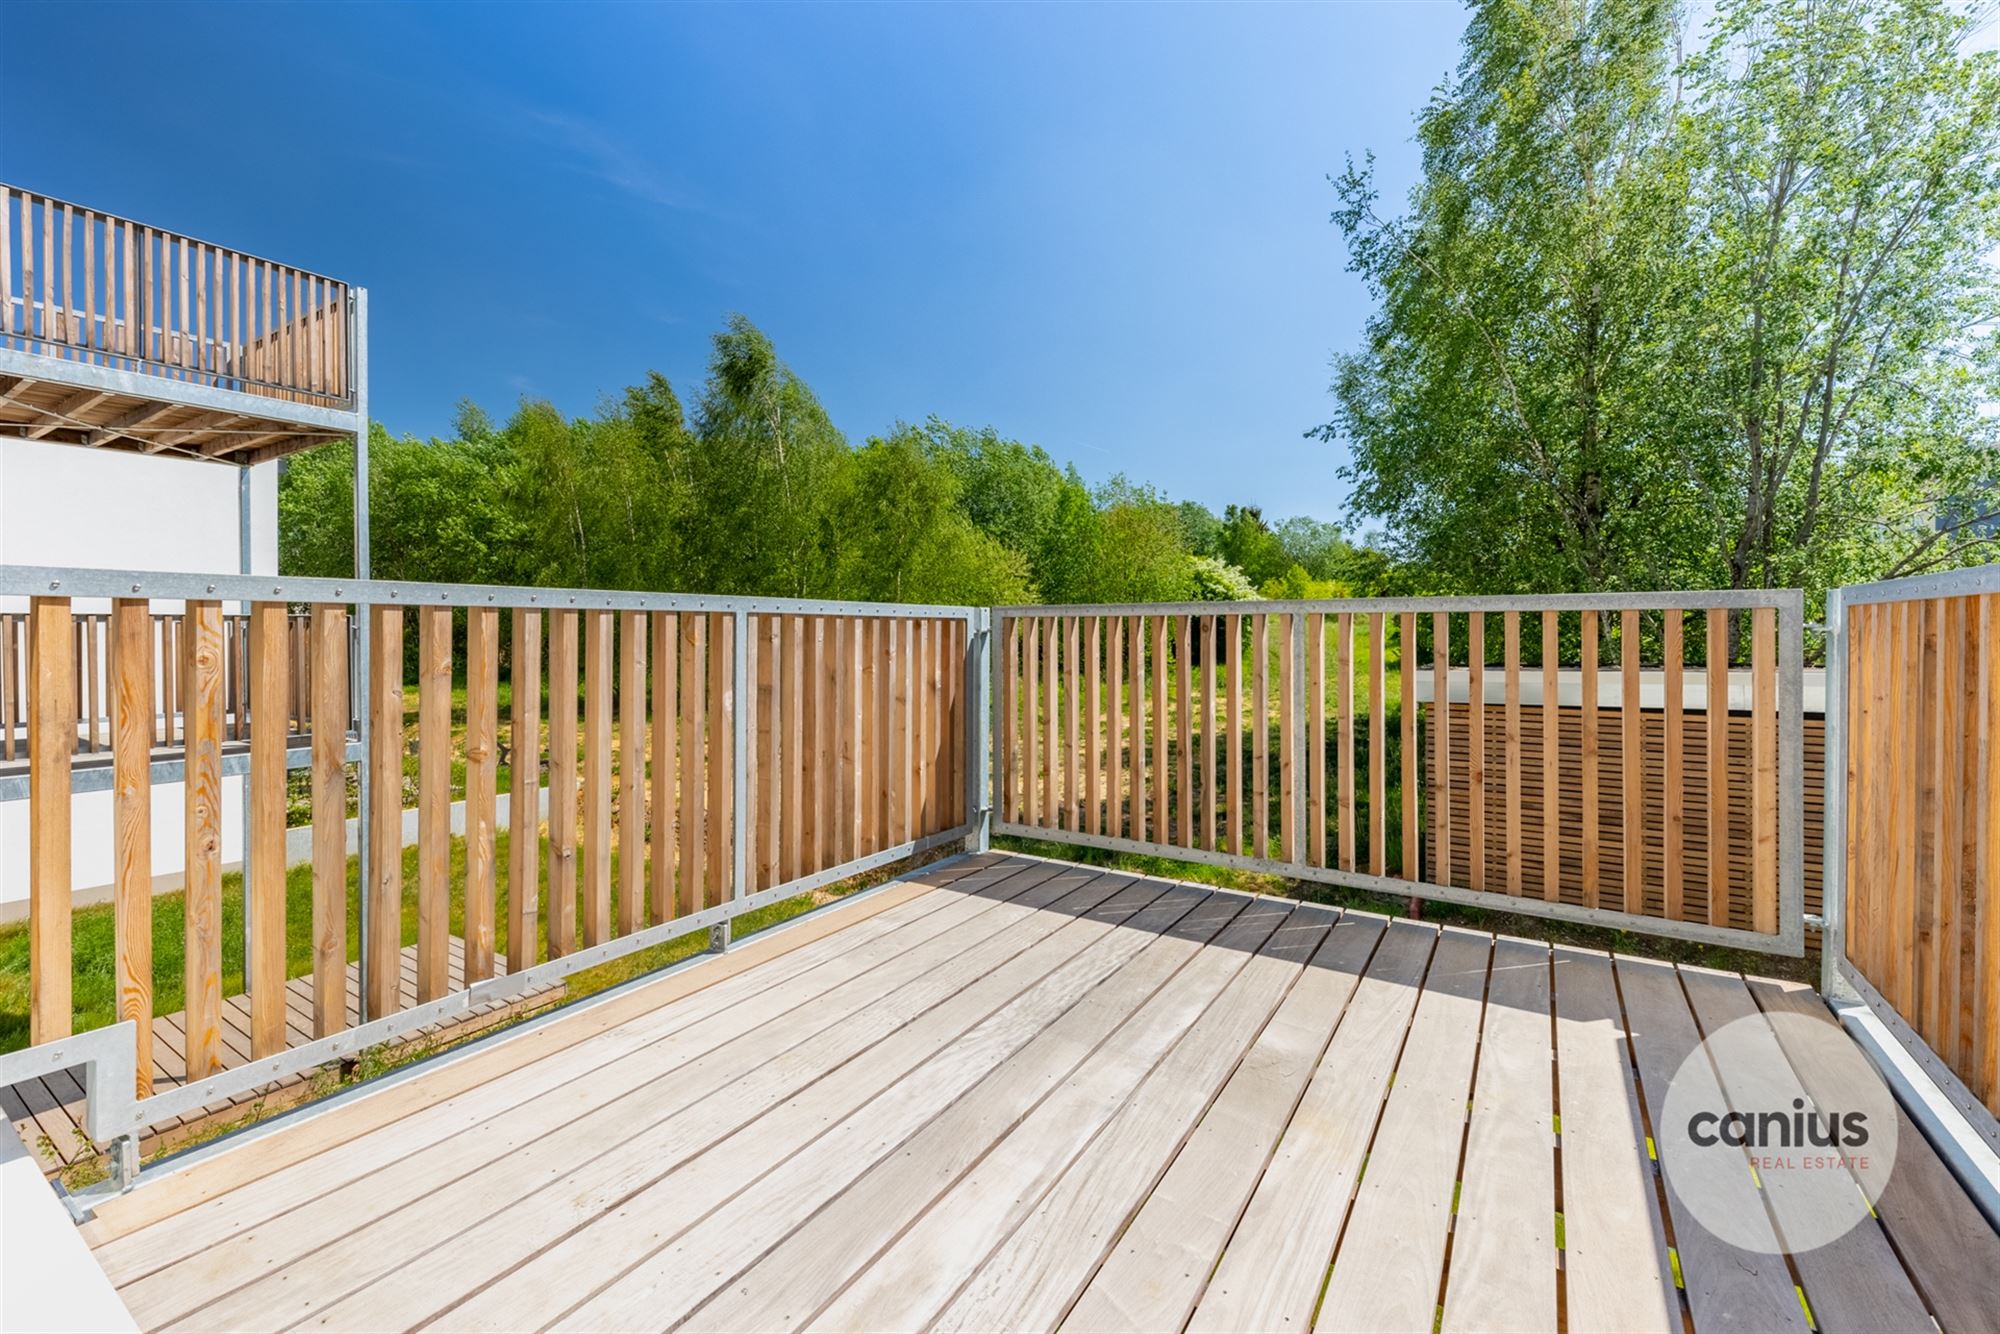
xmin=0 ymin=182 xmax=366 ymax=464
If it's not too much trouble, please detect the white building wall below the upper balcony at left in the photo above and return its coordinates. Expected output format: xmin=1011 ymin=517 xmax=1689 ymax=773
xmin=0 ymin=436 xmax=278 ymax=922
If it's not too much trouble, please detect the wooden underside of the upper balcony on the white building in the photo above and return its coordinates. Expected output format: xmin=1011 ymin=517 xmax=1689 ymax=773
xmin=0 ymin=376 xmax=348 ymax=464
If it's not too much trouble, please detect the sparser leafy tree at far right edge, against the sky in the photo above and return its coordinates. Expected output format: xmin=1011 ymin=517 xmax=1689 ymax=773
xmin=1654 ymin=0 xmax=2000 ymax=586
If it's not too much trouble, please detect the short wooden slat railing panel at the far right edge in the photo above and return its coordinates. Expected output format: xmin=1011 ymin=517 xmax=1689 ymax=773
xmin=1828 ymin=580 xmax=2000 ymax=1114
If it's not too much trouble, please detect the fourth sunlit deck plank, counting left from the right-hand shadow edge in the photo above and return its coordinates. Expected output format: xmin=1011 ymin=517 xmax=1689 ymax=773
xmin=1188 ymin=922 xmax=1438 ymax=1330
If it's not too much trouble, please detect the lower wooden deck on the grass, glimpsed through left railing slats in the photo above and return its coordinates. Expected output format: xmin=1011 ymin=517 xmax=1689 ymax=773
xmin=0 ymin=936 xmax=562 ymax=1174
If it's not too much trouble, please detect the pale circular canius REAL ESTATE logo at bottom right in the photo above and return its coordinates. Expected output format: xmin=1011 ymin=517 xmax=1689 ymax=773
xmin=1654 ymin=1014 xmax=1896 ymax=1254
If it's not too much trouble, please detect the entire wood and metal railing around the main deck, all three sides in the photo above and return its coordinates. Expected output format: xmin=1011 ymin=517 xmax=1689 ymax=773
xmin=0 ymin=566 xmax=2000 ymax=1200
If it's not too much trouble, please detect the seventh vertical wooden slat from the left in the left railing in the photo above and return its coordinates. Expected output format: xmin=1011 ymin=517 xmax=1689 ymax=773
xmin=416 ymin=606 xmax=452 ymax=1004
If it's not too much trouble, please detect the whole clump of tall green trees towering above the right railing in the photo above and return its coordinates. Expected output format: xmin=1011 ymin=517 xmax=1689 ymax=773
xmin=1314 ymin=0 xmax=2000 ymax=590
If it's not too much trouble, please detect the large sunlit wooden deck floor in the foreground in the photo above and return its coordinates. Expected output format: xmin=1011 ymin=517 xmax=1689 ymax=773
xmin=66 ymin=856 xmax=2000 ymax=1332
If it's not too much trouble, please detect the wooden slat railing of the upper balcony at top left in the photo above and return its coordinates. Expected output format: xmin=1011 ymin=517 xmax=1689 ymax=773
xmin=0 ymin=184 xmax=352 ymax=406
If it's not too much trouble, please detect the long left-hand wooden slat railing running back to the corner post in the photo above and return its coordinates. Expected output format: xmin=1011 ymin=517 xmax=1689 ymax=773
xmin=0 ymin=572 xmax=972 ymax=1120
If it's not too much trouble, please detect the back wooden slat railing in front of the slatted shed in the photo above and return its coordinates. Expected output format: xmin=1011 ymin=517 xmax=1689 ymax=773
xmin=996 ymin=594 xmax=1802 ymax=952
